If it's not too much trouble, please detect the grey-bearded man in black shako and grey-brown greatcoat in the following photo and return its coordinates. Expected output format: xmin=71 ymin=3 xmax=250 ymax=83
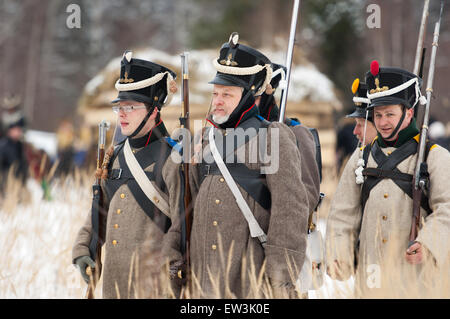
xmin=165 ymin=34 xmax=308 ymax=298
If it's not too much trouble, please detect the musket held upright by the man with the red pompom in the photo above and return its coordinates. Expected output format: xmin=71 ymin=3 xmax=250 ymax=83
xmin=409 ymin=1 xmax=444 ymax=246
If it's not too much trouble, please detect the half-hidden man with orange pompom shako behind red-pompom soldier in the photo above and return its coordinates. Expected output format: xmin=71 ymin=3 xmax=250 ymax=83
xmin=346 ymin=79 xmax=377 ymax=146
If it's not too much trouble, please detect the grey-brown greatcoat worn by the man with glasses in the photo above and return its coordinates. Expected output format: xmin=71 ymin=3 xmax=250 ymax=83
xmin=72 ymin=140 xmax=180 ymax=298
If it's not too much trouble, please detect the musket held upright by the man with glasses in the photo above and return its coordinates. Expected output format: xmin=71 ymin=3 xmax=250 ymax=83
xmin=86 ymin=120 xmax=109 ymax=299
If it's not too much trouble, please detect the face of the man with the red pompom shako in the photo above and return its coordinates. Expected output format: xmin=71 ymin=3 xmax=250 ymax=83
xmin=373 ymin=104 xmax=414 ymax=141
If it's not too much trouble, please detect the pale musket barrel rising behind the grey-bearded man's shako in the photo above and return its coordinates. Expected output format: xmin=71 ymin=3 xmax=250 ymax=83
xmin=279 ymin=0 xmax=300 ymax=123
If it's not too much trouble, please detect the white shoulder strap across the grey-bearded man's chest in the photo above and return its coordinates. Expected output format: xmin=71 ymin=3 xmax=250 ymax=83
xmin=209 ymin=128 xmax=267 ymax=247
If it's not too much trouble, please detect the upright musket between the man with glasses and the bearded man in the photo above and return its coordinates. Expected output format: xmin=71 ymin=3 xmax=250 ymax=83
xmin=177 ymin=52 xmax=192 ymax=290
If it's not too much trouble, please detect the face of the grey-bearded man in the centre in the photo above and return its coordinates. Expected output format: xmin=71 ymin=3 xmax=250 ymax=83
xmin=211 ymin=84 xmax=242 ymax=124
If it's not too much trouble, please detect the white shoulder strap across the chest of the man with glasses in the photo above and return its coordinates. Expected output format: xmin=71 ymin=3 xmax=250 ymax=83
xmin=123 ymin=139 xmax=170 ymax=218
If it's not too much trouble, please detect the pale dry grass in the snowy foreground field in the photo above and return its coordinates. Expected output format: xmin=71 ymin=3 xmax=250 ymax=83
xmin=0 ymin=171 xmax=450 ymax=299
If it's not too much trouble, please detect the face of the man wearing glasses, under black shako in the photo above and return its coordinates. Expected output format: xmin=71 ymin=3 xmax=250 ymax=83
xmin=119 ymin=101 xmax=157 ymax=137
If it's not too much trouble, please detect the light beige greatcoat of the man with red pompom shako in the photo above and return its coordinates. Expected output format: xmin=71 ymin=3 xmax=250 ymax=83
xmin=326 ymin=139 xmax=450 ymax=298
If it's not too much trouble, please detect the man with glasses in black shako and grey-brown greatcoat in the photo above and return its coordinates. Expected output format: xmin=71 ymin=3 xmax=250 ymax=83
xmin=72 ymin=51 xmax=180 ymax=298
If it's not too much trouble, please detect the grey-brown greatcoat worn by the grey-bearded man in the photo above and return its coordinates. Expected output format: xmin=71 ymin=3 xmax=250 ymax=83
xmin=165 ymin=118 xmax=309 ymax=298
